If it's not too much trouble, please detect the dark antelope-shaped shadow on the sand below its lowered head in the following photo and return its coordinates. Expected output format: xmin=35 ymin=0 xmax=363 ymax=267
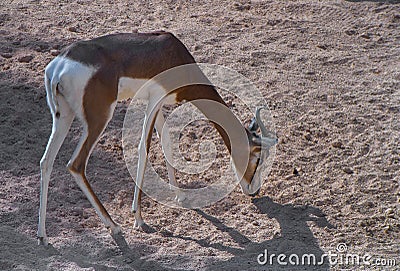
xmin=162 ymin=197 xmax=333 ymax=271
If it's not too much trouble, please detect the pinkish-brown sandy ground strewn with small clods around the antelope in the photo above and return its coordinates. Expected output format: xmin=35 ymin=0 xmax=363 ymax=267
xmin=0 ymin=0 xmax=400 ymax=270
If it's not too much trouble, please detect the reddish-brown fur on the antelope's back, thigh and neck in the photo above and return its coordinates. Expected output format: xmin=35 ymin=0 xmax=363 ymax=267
xmin=62 ymin=32 xmax=257 ymax=230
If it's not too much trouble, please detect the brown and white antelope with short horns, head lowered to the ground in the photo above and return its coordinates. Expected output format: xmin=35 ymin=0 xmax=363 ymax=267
xmin=37 ymin=31 xmax=277 ymax=245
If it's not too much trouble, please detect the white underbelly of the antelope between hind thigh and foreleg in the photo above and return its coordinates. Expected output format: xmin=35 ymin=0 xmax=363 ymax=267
xmin=117 ymin=77 xmax=176 ymax=104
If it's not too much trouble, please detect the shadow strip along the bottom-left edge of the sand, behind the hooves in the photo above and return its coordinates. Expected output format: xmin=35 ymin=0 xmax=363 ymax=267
xmin=0 ymin=226 xmax=178 ymax=271
